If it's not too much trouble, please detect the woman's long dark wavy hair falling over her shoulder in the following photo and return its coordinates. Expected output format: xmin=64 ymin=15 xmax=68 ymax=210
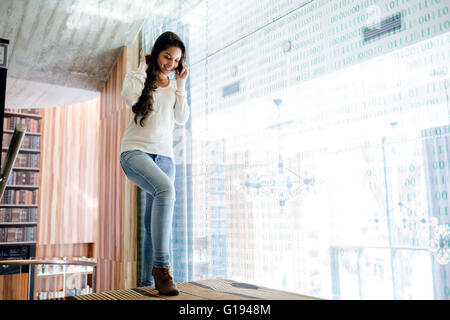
xmin=131 ymin=31 xmax=186 ymax=127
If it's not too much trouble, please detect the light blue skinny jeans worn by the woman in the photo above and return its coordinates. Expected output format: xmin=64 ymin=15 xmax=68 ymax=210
xmin=120 ymin=150 xmax=175 ymax=286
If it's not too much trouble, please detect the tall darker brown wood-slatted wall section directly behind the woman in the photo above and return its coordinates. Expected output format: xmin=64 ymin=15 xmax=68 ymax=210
xmin=96 ymin=40 xmax=139 ymax=291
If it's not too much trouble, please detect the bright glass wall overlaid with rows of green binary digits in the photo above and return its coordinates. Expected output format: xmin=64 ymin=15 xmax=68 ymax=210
xmin=144 ymin=0 xmax=450 ymax=299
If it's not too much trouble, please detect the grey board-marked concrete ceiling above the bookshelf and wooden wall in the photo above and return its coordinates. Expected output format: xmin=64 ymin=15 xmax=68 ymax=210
xmin=0 ymin=0 xmax=199 ymax=108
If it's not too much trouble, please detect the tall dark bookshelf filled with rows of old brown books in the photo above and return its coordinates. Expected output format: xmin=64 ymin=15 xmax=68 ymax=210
xmin=0 ymin=109 xmax=42 ymax=299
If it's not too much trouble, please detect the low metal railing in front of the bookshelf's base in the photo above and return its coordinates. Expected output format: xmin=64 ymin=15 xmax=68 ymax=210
xmin=0 ymin=258 xmax=97 ymax=300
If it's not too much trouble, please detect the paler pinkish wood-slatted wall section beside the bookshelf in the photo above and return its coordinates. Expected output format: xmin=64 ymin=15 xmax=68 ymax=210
xmin=37 ymin=98 xmax=100 ymax=246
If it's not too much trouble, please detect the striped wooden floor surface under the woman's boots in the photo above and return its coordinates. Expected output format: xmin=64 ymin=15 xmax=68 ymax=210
xmin=57 ymin=279 xmax=320 ymax=300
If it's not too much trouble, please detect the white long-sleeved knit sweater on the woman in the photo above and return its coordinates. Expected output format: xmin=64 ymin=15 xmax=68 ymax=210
xmin=120 ymin=63 xmax=190 ymax=159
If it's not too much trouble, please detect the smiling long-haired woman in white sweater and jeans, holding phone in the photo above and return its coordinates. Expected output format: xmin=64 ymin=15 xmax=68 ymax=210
xmin=120 ymin=32 xmax=189 ymax=295
